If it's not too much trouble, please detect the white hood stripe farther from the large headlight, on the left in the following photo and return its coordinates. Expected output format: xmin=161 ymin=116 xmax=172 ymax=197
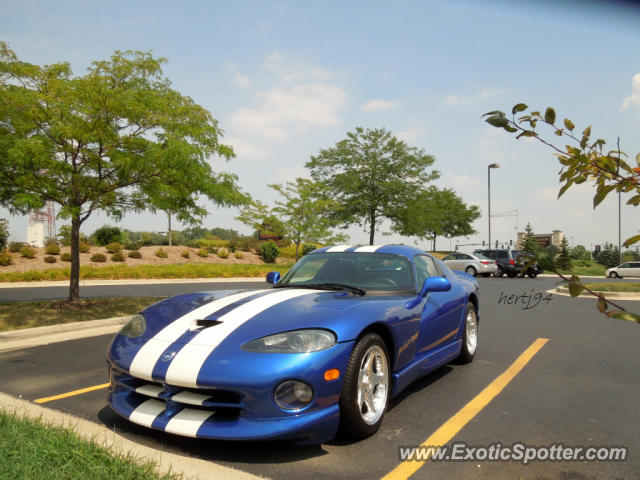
xmin=129 ymin=290 xmax=267 ymax=380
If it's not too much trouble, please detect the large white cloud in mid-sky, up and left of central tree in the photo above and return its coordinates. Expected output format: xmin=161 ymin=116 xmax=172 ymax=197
xmin=230 ymin=52 xmax=347 ymax=140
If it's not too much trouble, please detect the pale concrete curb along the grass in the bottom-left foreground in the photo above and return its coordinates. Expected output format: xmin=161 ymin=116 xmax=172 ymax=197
xmin=0 ymin=393 xmax=264 ymax=480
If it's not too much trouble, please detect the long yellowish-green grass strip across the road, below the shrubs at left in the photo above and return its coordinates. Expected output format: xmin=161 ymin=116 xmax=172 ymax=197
xmin=0 ymin=262 xmax=293 ymax=282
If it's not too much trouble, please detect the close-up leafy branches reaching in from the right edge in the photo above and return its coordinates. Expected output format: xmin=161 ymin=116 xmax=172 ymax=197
xmin=483 ymin=103 xmax=640 ymax=324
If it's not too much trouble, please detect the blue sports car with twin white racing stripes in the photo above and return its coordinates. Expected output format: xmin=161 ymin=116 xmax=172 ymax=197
xmin=108 ymin=245 xmax=479 ymax=443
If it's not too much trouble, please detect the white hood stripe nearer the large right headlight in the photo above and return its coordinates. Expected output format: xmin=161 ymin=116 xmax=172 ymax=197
xmin=166 ymin=289 xmax=318 ymax=387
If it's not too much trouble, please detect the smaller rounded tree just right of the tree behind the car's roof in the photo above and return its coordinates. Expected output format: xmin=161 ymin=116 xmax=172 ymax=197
xmin=392 ymin=187 xmax=480 ymax=251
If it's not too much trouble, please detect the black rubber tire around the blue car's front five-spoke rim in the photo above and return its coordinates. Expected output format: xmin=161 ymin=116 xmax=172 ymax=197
xmin=339 ymin=333 xmax=391 ymax=439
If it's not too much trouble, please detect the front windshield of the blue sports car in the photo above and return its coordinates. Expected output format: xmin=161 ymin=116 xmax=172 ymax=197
xmin=276 ymin=252 xmax=415 ymax=292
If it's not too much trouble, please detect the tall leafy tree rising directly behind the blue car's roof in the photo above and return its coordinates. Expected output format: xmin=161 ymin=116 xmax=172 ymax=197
xmin=306 ymin=127 xmax=439 ymax=245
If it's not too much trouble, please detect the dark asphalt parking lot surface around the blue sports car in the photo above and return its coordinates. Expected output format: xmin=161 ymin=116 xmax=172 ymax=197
xmin=0 ymin=278 xmax=640 ymax=480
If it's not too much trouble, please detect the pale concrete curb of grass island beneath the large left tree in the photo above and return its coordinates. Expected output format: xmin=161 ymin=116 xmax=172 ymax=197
xmin=0 ymin=315 xmax=131 ymax=352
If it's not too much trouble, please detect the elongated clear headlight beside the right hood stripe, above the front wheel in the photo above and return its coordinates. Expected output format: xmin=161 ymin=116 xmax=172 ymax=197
xmin=242 ymin=329 xmax=336 ymax=353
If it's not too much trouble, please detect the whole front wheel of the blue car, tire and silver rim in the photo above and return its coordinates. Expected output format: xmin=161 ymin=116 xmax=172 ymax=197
xmin=339 ymin=333 xmax=391 ymax=438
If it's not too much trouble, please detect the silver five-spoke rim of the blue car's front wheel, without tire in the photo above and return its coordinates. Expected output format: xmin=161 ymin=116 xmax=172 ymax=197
xmin=357 ymin=345 xmax=389 ymax=425
